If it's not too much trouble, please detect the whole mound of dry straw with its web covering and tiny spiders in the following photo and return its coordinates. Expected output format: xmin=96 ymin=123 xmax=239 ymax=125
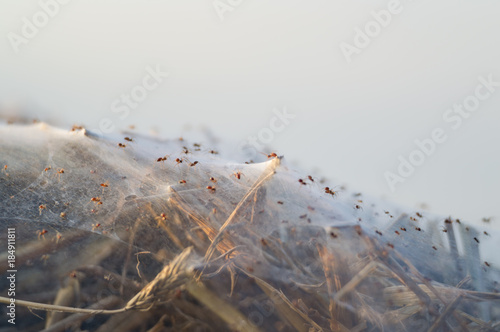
xmin=0 ymin=124 xmax=500 ymax=331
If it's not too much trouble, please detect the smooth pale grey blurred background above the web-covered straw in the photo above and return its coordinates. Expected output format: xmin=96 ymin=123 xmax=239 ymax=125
xmin=0 ymin=0 xmax=500 ymax=226
